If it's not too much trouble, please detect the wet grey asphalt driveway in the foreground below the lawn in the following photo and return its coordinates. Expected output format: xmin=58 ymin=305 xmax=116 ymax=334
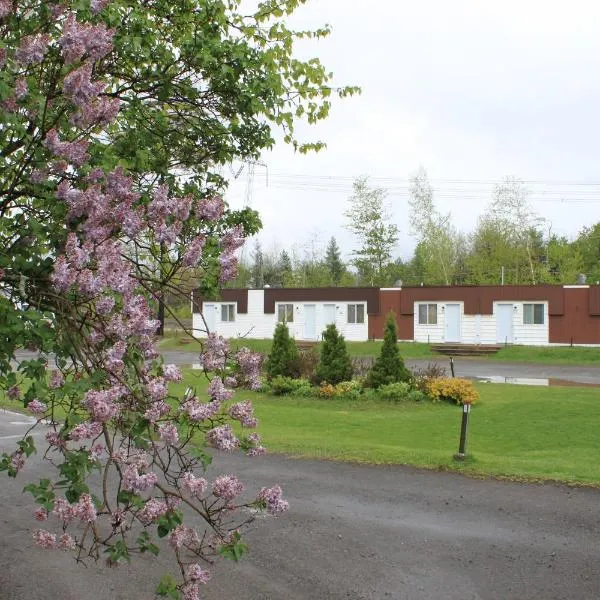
xmin=0 ymin=412 xmax=600 ymax=600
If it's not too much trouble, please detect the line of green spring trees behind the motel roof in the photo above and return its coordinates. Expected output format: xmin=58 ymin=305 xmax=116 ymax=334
xmin=176 ymin=169 xmax=600 ymax=304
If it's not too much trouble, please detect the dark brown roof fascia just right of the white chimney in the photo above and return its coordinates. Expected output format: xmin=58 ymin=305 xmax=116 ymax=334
xmin=264 ymin=288 xmax=380 ymax=315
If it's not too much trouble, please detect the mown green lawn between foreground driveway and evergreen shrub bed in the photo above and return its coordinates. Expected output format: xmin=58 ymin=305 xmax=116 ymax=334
xmin=7 ymin=371 xmax=600 ymax=486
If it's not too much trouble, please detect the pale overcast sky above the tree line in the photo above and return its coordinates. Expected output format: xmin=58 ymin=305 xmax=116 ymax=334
xmin=227 ymin=0 xmax=600 ymax=258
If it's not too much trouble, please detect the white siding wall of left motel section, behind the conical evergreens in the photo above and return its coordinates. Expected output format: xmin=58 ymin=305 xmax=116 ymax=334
xmin=193 ymin=290 xmax=369 ymax=341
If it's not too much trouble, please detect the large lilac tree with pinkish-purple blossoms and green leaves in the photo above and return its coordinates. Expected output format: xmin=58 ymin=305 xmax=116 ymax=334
xmin=0 ymin=0 xmax=355 ymax=599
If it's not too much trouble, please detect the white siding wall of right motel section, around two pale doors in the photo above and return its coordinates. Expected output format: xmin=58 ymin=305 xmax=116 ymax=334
xmin=413 ymin=300 xmax=550 ymax=346
